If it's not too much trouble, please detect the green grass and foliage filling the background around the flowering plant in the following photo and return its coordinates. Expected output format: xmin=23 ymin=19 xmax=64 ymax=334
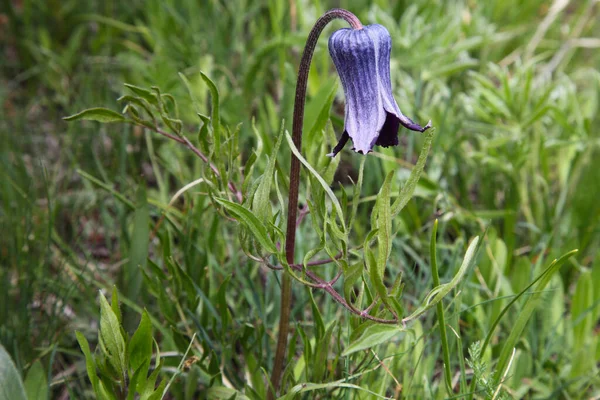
xmin=0 ymin=0 xmax=600 ymax=399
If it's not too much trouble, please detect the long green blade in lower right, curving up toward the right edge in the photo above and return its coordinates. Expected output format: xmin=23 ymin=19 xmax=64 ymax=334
xmin=494 ymin=250 xmax=577 ymax=382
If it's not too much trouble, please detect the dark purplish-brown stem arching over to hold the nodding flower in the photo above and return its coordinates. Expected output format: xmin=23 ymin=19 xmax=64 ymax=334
xmin=267 ymin=8 xmax=362 ymax=400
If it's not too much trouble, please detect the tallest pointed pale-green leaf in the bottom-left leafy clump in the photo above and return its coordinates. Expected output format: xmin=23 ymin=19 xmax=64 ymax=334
xmin=100 ymin=292 xmax=126 ymax=376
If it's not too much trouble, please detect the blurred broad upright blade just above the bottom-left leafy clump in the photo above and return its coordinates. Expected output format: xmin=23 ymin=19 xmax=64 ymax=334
xmin=123 ymin=183 xmax=150 ymax=301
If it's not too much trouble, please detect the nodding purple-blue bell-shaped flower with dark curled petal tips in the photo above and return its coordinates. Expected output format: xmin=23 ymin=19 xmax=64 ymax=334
xmin=328 ymin=24 xmax=431 ymax=157
